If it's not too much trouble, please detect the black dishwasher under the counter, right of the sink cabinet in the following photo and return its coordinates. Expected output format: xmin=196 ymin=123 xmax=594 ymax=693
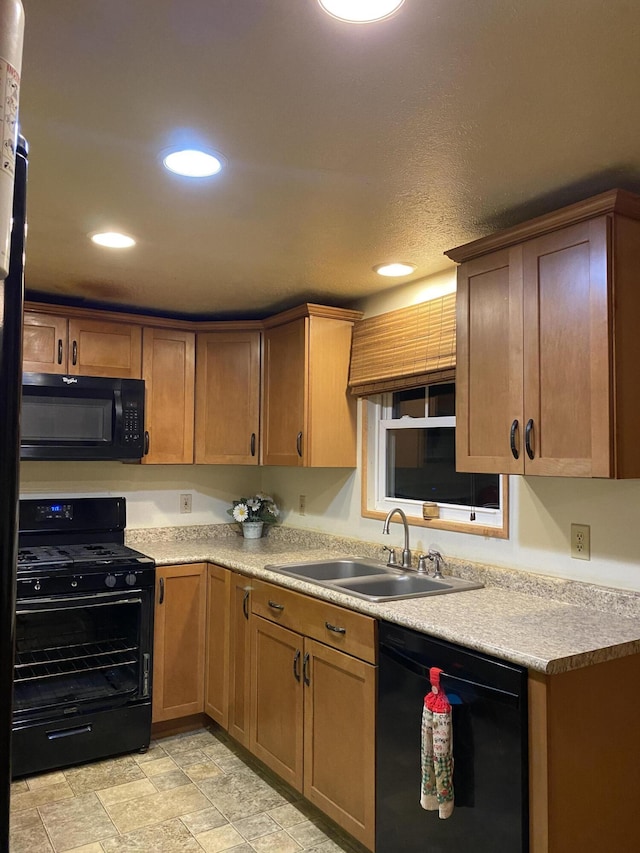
xmin=376 ymin=622 xmax=529 ymax=853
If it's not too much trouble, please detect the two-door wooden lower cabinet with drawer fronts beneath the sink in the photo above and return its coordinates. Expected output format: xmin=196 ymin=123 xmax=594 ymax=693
xmin=249 ymin=584 xmax=377 ymax=849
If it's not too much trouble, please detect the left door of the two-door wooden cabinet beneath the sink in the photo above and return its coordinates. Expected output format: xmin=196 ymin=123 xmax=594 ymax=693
xmin=250 ymin=615 xmax=304 ymax=791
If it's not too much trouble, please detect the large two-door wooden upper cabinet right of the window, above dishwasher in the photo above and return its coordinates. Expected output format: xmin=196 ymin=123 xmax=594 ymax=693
xmin=447 ymin=191 xmax=640 ymax=477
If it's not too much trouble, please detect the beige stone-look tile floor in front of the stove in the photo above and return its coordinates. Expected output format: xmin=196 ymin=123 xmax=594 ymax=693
xmin=10 ymin=726 xmax=364 ymax=853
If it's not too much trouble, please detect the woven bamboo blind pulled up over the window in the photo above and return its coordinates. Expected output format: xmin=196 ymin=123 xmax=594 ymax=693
xmin=349 ymin=293 xmax=456 ymax=397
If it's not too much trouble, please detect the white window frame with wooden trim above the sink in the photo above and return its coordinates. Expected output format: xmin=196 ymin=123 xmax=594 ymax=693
xmin=361 ymin=392 xmax=509 ymax=539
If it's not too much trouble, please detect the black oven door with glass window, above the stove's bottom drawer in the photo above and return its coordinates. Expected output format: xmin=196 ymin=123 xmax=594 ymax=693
xmin=13 ymin=589 xmax=153 ymax=729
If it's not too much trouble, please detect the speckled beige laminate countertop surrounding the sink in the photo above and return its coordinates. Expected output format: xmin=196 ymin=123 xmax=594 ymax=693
xmin=127 ymin=525 xmax=640 ymax=674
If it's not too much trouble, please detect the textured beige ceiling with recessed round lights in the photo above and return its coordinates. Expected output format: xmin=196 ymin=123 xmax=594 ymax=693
xmin=21 ymin=0 xmax=640 ymax=317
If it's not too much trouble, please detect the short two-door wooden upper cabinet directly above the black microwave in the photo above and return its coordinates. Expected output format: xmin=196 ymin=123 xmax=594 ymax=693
xmin=23 ymin=311 xmax=142 ymax=379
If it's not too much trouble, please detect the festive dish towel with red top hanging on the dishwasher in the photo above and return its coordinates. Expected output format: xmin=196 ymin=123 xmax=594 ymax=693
xmin=420 ymin=666 xmax=453 ymax=819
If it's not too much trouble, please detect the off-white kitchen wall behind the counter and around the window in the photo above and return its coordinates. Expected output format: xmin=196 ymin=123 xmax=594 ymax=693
xmin=20 ymin=271 xmax=640 ymax=590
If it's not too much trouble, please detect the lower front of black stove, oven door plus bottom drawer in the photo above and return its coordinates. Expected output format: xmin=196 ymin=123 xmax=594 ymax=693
xmin=12 ymin=589 xmax=153 ymax=777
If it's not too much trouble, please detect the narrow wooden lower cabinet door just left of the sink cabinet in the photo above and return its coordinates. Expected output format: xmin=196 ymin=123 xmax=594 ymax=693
xmin=229 ymin=572 xmax=251 ymax=747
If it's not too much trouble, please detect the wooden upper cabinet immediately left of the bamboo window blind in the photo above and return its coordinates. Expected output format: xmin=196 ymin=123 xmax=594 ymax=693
xmin=262 ymin=306 xmax=360 ymax=468
